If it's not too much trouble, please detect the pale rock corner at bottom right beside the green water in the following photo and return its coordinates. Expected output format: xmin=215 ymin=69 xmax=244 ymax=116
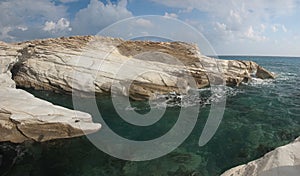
xmin=222 ymin=137 xmax=300 ymax=176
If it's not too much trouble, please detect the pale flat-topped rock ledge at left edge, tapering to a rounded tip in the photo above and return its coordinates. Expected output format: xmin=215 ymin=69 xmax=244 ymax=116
xmin=0 ymin=40 xmax=101 ymax=143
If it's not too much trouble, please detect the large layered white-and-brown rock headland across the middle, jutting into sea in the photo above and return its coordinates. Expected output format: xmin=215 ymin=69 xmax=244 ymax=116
xmin=5 ymin=36 xmax=272 ymax=100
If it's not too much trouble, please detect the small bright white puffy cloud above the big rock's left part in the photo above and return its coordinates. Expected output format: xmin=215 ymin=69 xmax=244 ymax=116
xmin=43 ymin=18 xmax=72 ymax=33
